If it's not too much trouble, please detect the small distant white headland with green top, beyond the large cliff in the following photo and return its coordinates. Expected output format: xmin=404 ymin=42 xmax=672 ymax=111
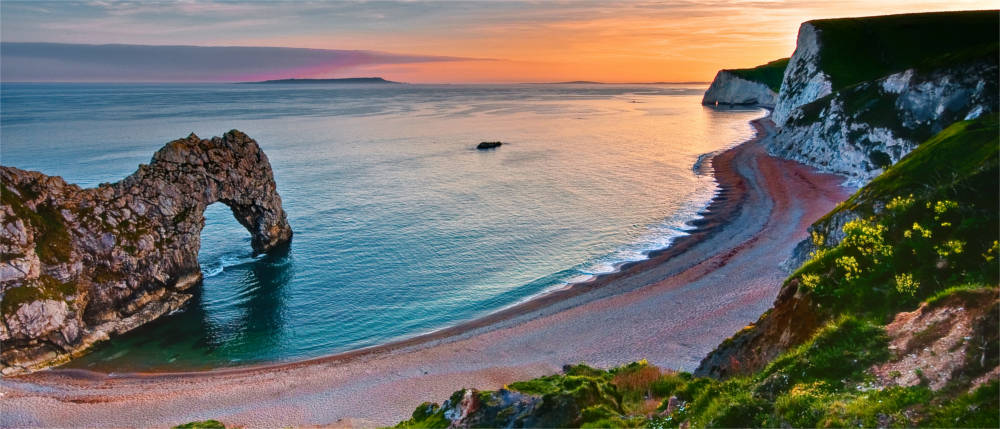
xmin=701 ymin=59 xmax=788 ymax=108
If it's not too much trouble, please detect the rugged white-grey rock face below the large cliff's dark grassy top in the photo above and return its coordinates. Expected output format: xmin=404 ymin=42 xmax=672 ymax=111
xmin=766 ymin=55 xmax=1000 ymax=185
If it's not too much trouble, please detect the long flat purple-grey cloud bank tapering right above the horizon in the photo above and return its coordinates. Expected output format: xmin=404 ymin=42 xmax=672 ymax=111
xmin=0 ymin=42 xmax=483 ymax=82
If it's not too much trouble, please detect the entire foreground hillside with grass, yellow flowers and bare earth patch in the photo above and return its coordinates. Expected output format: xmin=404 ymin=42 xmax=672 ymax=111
xmin=398 ymin=115 xmax=1000 ymax=428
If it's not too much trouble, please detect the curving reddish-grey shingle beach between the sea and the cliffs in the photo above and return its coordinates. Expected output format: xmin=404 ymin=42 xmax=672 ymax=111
xmin=0 ymin=119 xmax=850 ymax=427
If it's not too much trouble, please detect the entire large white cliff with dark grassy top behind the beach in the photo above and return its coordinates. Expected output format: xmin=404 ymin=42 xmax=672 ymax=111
xmin=767 ymin=11 xmax=1000 ymax=185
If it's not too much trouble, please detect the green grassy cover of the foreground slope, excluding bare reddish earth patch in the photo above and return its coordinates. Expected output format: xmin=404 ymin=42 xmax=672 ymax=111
xmin=400 ymin=115 xmax=1000 ymax=427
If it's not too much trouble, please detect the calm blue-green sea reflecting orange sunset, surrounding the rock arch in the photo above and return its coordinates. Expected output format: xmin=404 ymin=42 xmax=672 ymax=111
xmin=0 ymin=84 xmax=761 ymax=371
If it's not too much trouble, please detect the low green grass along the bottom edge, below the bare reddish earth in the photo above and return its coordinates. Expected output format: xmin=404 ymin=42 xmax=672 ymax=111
xmin=397 ymin=315 xmax=1000 ymax=428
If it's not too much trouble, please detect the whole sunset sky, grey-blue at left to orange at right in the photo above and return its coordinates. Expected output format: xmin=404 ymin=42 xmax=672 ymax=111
xmin=0 ymin=0 xmax=997 ymax=83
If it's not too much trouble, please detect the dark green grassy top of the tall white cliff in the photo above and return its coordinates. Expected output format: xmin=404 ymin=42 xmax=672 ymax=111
xmin=809 ymin=10 xmax=1000 ymax=91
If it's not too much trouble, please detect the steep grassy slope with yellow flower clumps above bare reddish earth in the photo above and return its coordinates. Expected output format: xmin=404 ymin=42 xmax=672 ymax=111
xmin=792 ymin=114 xmax=1000 ymax=318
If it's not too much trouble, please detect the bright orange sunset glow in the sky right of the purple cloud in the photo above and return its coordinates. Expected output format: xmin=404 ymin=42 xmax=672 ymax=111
xmin=232 ymin=1 xmax=995 ymax=83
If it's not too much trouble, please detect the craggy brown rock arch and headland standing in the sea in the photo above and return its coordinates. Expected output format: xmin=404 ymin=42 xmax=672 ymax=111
xmin=0 ymin=130 xmax=292 ymax=374
